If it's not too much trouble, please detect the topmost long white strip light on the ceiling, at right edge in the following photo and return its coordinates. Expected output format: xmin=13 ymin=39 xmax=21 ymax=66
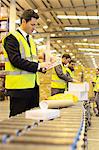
xmin=57 ymin=15 xmax=99 ymax=20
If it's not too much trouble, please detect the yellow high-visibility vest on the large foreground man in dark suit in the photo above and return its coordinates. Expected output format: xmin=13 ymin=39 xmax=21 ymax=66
xmin=3 ymin=31 xmax=39 ymax=89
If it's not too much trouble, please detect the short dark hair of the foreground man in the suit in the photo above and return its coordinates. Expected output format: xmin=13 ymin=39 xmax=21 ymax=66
xmin=20 ymin=9 xmax=39 ymax=23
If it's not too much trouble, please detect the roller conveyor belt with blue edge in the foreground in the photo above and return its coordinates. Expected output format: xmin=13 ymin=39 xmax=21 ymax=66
xmin=0 ymin=103 xmax=88 ymax=150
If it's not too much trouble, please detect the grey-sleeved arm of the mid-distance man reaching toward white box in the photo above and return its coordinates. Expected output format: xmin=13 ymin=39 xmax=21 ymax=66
xmin=55 ymin=65 xmax=73 ymax=82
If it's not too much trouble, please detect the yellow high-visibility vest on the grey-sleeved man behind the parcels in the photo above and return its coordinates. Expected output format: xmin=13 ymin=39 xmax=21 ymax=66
xmin=51 ymin=65 xmax=67 ymax=89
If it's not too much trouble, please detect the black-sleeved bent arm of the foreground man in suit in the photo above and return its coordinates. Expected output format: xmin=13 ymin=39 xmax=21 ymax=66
xmin=4 ymin=34 xmax=38 ymax=73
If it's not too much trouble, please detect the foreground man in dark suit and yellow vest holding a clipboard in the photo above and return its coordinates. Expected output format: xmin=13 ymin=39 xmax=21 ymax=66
xmin=3 ymin=9 xmax=50 ymax=117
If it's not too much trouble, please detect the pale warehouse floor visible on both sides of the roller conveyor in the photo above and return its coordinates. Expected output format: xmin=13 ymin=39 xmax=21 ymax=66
xmin=0 ymin=100 xmax=99 ymax=150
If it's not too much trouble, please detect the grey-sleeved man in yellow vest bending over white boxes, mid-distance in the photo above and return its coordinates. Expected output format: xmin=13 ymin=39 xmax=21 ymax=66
xmin=51 ymin=54 xmax=73 ymax=95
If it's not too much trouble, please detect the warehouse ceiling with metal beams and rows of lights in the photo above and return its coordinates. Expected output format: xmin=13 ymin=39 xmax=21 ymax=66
xmin=1 ymin=0 xmax=99 ymax=68
